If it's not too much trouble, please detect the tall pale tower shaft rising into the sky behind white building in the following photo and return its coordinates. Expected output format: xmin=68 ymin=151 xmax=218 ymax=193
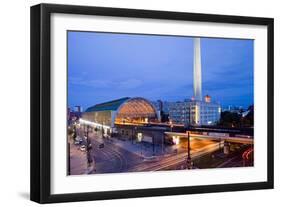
xmin=193 ymin=38 xmax=202 ymax=101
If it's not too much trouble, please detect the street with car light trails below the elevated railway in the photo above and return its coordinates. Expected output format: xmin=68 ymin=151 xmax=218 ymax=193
xmin=70 ymin=124 xmax=252 ymax=174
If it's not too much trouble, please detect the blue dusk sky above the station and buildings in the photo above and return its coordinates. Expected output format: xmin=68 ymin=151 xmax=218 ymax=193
xmin=68 ymin=32 xmax=254 ymax=110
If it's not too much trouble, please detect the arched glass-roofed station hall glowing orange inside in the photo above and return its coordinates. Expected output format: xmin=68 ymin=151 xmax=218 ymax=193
xmin=80 ymin=97 xmax=159 ymax=134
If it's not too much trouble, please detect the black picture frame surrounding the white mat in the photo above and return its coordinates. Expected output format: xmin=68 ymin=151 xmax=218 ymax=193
xmin=30 ymin=4 xmax=274 ymax=203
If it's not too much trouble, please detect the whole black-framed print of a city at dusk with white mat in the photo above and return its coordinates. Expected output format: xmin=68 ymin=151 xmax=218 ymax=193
xmin=31 ymin=4 xmax=273 ymax=203
